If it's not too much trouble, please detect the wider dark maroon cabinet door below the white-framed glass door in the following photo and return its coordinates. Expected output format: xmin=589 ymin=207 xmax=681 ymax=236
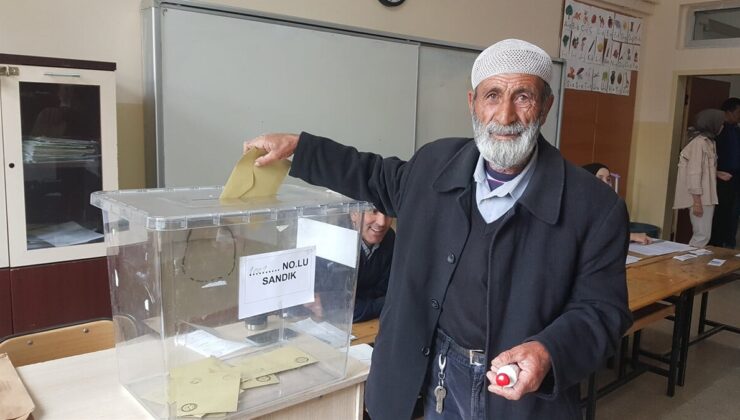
xmin=10 ymin=258 xmax=111 ymax=334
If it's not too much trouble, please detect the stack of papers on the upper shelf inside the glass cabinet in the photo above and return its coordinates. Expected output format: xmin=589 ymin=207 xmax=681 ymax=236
xmin=23 ymin=137 xmax=100 ymax=163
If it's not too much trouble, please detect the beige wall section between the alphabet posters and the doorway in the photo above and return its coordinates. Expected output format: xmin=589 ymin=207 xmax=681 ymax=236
xmin=628 ymin=0 xmax=740 ymax=236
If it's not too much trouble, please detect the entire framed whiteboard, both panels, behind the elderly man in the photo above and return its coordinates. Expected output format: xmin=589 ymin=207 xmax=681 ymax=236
xmin=150 ymin=2 xmax=563 ymax=187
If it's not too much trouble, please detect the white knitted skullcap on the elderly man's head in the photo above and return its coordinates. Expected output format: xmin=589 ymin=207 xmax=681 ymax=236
xmin=470 ymin=39 xmax=552 ymax=89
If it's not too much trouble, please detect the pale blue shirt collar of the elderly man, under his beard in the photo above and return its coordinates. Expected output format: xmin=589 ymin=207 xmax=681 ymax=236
xmin=473 ymin=148 xmax=537 ymax=223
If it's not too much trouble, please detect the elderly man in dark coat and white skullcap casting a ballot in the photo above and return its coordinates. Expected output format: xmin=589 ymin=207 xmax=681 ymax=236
xmin=244 ymin=40 xmax=631 ymax=420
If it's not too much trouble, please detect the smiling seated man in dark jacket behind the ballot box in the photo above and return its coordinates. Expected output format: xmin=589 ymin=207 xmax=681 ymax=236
xmin=350 ymin=209 xmax=396 ymax=322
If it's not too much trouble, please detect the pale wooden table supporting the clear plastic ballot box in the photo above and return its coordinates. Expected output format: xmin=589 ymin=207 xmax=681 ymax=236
xmin=17 ymin=349 xmax=369 ymax=420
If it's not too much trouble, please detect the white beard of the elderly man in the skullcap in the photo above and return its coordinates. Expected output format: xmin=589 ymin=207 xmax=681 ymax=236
xmin=473 ymin=114 xmax=540 ymax=169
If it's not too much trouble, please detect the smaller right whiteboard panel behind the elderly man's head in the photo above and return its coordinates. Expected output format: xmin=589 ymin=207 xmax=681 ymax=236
xmin=416 ymin=45 xmax=563 ymax=150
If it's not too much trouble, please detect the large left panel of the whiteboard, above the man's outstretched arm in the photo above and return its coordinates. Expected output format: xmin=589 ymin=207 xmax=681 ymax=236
xmin=158 ymin=7 xmax=419 ymax=187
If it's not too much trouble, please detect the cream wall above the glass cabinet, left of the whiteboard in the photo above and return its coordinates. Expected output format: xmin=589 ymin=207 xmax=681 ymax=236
xmin=0 ymin=0 xmax=144 ymax=188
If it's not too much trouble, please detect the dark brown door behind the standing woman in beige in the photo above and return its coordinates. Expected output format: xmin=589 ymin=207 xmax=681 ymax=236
xmin=669 ymin=77 xmax=730 ymax=244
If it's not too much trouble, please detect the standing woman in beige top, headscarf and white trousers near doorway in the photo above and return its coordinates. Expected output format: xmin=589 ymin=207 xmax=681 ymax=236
xmin=673 ymin=109 xmax=732 ymax=248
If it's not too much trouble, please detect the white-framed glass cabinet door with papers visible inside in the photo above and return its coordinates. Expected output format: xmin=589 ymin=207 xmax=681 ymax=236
xmin=0 ymin=66 xmax=118 ymax=267
